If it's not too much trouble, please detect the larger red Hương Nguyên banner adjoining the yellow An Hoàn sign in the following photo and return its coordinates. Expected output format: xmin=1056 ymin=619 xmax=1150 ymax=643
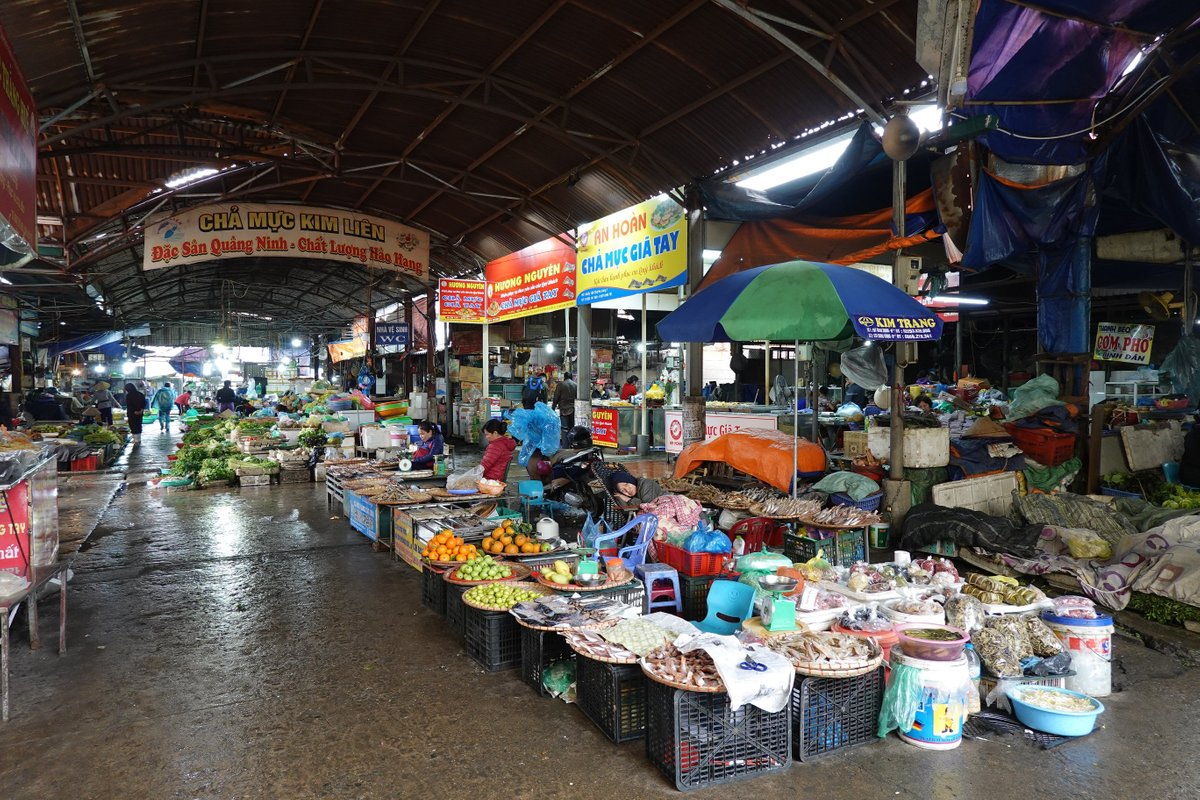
xmin=484 ymin=239 xmax=575 ymax=323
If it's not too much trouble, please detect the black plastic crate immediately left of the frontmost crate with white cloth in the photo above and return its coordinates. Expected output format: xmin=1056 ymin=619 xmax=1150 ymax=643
xmin=575 ymin=656 xmax=646 ymax=745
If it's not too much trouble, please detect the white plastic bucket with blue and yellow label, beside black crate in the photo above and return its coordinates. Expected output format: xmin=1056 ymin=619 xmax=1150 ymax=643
xmin=892 ymin=646 xmax=972 ymax=750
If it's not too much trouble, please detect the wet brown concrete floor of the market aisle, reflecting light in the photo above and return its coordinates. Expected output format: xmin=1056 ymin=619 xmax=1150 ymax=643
xmin=0 ymin=434 xmax=1200 ymax=800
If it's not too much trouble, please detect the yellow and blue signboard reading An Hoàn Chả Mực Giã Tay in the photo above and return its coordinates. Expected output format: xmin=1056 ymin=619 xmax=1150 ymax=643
xmin=577 ymin=194 xmax=688 ymax=306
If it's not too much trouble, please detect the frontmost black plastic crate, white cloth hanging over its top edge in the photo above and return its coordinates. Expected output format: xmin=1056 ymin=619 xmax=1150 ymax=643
xmin=646 ymin=680 xmax=792 ymax=790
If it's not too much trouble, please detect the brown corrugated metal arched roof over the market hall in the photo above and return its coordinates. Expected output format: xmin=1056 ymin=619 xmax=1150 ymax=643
xmin=0 ymin=0 xmax=924 ymax=324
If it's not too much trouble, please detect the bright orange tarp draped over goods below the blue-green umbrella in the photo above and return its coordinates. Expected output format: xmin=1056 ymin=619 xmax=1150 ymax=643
xmin=674 ymin=428 xmax=826 ymax=492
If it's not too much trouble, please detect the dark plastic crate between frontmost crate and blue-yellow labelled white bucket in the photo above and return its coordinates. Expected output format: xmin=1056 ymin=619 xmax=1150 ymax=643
xmin=792 ymin=667 xmax=883 ymax=762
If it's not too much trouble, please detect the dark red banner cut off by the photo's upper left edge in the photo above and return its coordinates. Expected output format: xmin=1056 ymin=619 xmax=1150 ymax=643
xmin=0 ymin=29 xmax=37 ymax=248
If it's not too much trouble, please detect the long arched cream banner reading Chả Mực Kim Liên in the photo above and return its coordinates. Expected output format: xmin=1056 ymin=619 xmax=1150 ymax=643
xmin=142 ymin=203 xmax=430 ymax=283
